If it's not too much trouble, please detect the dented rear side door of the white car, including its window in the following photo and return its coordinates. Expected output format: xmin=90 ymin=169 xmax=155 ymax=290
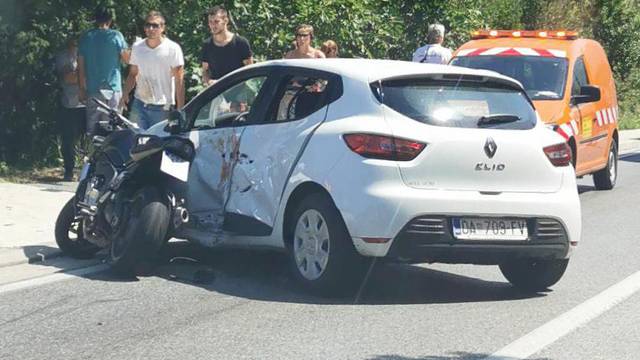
xmin=225 ymin=67 xmax=341 ymax=236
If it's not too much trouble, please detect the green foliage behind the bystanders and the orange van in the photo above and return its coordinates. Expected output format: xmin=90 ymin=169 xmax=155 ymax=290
xmin=0 ymin=0 xmax=640 ymax=165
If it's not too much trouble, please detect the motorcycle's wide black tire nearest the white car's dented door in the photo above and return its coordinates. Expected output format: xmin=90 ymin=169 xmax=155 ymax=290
xmin=109 ymin=187 xmax=170 ymax=275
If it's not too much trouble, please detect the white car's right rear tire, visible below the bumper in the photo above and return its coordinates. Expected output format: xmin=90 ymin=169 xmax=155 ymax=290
xmin=500 ymin=259 xmax=569 ymax=292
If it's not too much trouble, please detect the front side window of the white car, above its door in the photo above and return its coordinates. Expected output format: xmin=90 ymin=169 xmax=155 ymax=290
xmin=193 ymin=76 xmax=267 ymax=130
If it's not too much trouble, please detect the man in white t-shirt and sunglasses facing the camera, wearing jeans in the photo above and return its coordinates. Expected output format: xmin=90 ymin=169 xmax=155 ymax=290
xmin=121 ymin=11 xmax=184 ymax=129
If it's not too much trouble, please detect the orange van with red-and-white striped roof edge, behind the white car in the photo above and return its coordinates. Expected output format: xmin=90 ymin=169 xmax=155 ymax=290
xmin=450 ymin=30 xmax=618 ymax=190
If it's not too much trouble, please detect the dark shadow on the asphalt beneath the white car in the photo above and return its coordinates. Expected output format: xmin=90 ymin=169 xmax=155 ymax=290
xmin=27 ymin=242 xmax=546 ymax=305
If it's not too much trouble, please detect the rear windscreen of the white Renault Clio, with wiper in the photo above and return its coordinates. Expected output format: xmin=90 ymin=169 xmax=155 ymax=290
xmin=372 ymin=75 xmax=537 ymax=130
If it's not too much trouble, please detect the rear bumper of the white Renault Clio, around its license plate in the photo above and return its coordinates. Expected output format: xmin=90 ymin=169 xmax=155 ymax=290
xmin=322 ymin=146 xmax=582 ymax=263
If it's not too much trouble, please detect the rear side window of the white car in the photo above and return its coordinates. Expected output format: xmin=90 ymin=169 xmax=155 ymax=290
xmin=270 ymin=76 xmax=329 ymax=122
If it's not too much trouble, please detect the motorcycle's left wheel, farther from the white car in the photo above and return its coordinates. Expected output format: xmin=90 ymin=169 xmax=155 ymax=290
xmin=55 ymin=196 xmax=100 ymax=259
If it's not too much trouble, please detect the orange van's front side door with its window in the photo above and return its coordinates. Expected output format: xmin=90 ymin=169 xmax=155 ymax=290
xmin=571 ymin=56 xmax=607 ymax=173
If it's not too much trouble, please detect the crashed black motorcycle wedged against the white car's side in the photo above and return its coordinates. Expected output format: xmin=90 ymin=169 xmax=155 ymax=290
xmin=55 ymin=99 xmax=195 ymax=274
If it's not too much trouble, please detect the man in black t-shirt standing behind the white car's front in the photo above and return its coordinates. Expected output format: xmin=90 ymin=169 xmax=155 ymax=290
xmin=200 ymin=5 xmax=253 ymax=86
